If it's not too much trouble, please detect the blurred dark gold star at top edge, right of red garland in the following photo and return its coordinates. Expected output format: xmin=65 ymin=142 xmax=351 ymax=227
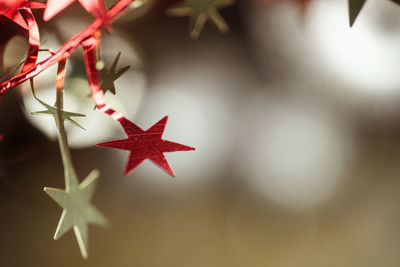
xmin=167 ymin=0 xmax=235 ymax=39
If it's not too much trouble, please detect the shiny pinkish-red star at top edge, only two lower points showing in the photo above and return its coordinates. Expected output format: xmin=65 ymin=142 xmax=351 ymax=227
xmin=43 ymin=0 xmax=106 ymax=21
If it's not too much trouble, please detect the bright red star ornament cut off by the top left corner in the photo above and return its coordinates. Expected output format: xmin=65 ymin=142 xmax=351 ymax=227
xmin=0 ymin=0 xmax=45 ymax=29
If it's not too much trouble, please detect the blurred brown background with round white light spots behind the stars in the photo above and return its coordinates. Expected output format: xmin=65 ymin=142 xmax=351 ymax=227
xmin=0 ymin=0 xmax=400 ymax=267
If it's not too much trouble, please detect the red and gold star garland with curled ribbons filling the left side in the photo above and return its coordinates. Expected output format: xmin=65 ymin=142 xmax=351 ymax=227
xmin=0 ymin=0 xmax=194 ymax=258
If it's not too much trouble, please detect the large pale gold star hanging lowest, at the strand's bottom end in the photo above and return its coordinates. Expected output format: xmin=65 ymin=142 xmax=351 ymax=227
xmin=44 ymin=170 xmax=108 ymax=258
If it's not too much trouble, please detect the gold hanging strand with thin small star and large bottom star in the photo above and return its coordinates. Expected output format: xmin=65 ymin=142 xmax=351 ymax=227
xmin=30 ymin=60 xmax=107 ymax=258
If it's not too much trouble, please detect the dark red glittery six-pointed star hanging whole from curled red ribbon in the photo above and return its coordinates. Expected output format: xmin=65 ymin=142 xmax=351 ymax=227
xmin=97 ymin=116 xmax=195 ymax=176
